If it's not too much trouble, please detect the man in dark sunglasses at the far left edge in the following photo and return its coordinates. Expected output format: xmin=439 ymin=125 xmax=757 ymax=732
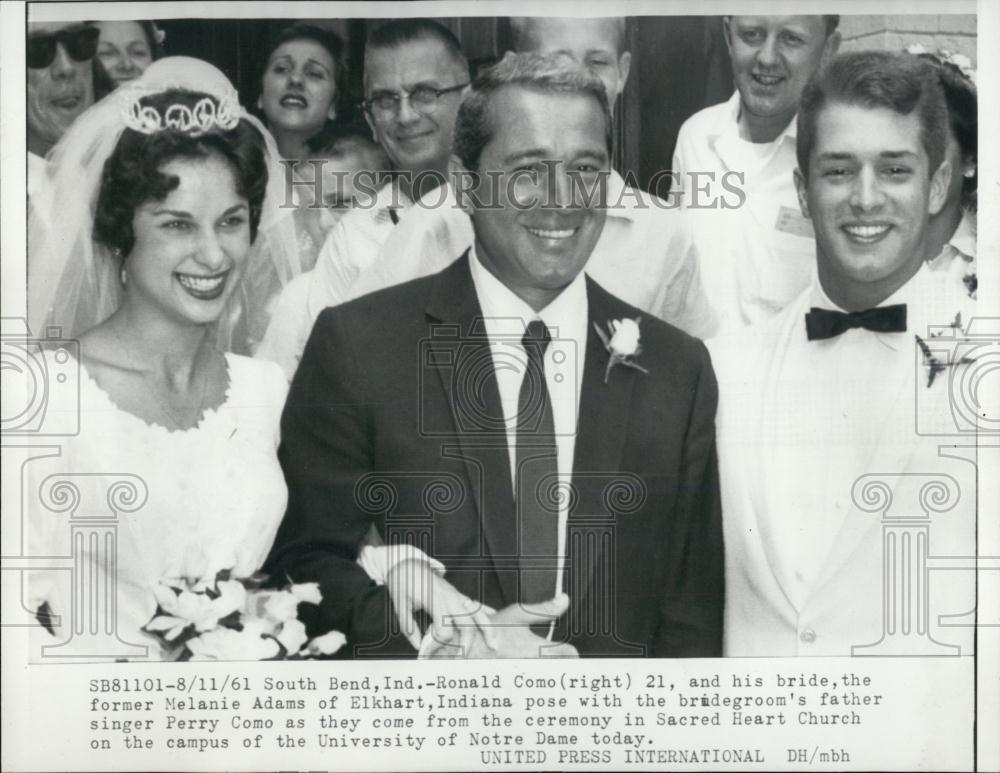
xmin=25 ymin=22 xmax=100 ymax=199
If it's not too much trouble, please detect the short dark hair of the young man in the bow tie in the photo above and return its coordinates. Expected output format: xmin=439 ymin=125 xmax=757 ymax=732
xmin=795 ymin=51 xmax=948 ymax=178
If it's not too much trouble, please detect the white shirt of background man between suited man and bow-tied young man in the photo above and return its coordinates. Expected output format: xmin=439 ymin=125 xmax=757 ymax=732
xmin=672 ymin=92 xmax=816 ymax=332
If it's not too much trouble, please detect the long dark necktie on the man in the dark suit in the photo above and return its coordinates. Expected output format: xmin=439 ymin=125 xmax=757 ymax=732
xmin=514 ymin=319 xmax=559 ymax=603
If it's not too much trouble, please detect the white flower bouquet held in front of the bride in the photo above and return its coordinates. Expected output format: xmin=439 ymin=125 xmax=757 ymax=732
xmin=143 ymin=570 xmax=345 ymax=660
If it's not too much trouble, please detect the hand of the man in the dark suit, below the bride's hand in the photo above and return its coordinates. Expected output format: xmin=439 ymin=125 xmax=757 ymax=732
xmin=423 ymin=593 xmax=579 ymax=659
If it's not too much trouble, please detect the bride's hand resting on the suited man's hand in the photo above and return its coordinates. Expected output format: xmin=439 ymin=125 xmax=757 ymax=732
xmin=385 ymin=559 xmax=497 ymax=657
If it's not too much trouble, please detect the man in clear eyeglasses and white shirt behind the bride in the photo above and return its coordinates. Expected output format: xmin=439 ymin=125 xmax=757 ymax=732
xmin=255 ymin=19 xmax=469 ymax=378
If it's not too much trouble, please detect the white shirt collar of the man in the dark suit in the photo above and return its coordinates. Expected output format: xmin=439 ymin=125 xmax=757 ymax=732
xmin=469 ymin=244 xmax=587 ymax=338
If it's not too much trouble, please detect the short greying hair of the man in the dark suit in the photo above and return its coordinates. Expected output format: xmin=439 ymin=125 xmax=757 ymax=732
xmin=454 ymin=52 xmax=613 ymax=171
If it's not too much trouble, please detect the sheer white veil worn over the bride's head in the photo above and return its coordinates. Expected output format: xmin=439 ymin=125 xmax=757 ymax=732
xmin=27 ymin=57 xmax=302 ymax=353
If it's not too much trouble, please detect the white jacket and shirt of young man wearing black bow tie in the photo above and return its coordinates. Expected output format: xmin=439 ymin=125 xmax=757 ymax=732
xmin=709 ymin=268 xmax=974 ymax=656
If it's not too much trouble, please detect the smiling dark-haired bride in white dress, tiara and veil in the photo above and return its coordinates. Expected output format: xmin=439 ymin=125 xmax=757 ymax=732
xmin=28 ymin=57 xmax=496 ymax=660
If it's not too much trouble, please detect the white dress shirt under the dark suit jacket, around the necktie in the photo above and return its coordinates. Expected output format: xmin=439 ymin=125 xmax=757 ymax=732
xmin=469 ymin=248 xmax=588 ymax=596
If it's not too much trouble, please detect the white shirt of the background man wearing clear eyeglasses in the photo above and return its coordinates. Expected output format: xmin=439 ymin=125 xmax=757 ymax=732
xmin=254 ymin=178 xmax=413 ymax=380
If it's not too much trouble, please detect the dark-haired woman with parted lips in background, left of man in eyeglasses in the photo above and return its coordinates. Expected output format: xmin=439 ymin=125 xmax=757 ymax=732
xmin=257 ymin=24 xmax=344 ymax=161
